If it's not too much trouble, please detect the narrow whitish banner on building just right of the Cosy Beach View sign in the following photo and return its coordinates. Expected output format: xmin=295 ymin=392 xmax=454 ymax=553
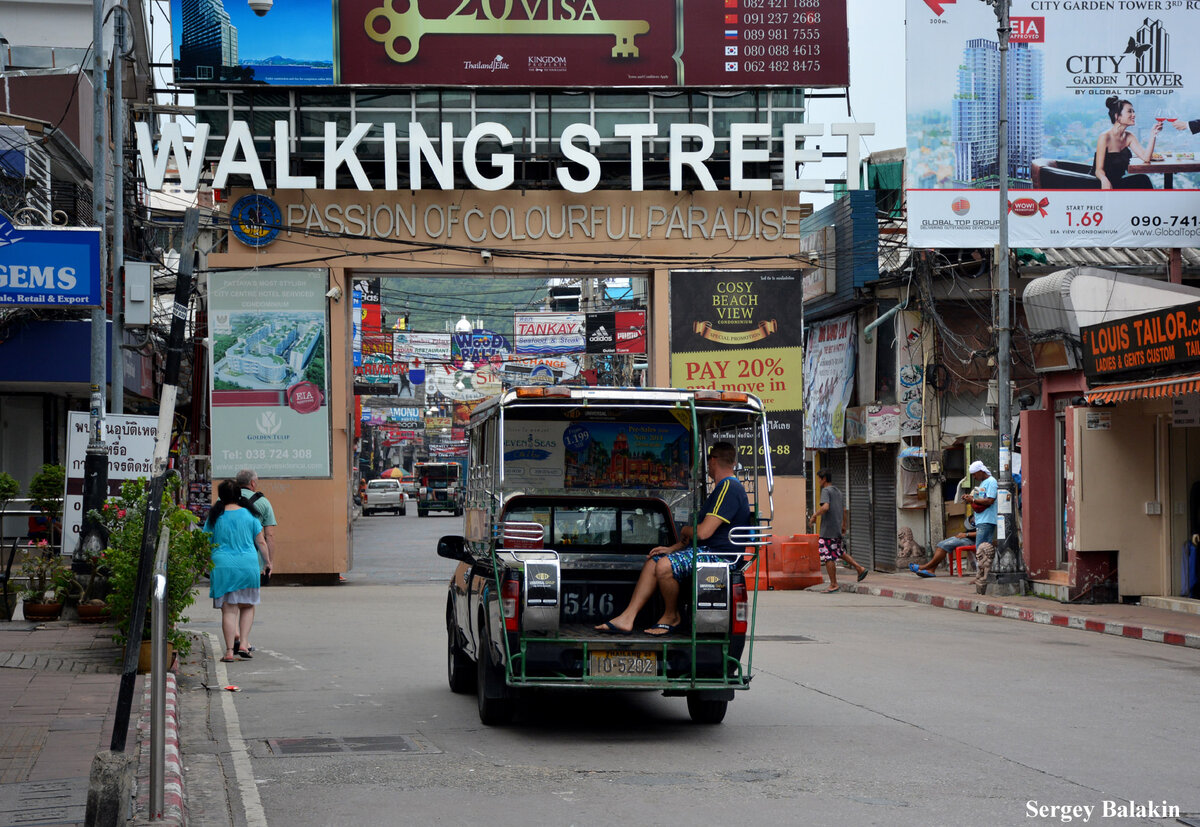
xmin=804 ymin=313 xmax=858 ymax=449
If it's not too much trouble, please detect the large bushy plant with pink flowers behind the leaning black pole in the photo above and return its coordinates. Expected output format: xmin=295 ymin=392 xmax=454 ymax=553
xmin=92 ymin=477 xmax=212 ymax=655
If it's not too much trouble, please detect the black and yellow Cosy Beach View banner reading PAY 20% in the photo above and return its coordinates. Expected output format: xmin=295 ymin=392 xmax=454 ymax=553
xmin=671 ymin=270 xmax=804 ymax=477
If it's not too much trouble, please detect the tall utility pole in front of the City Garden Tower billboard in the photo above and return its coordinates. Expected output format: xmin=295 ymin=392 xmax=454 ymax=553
xmin=985 ymin=0 xmax=1027 ymax=597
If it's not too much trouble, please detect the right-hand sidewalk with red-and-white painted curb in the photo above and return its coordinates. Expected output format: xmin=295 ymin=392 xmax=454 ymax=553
xmin=830 ymin=569 xmax=1200 ymax=648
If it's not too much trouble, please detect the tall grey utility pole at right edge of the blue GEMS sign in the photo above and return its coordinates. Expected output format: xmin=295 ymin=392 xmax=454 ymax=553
xmin=74 ymin=0 xmax=108 ymax=558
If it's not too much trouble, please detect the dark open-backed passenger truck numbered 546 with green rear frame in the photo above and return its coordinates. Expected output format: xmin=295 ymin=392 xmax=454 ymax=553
xmin=438 ymin=385 xmax=773 ymax=724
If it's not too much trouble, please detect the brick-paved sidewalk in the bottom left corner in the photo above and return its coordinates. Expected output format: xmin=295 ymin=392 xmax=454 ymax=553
xmin=0 ymin=621 xmax=165 ymax=825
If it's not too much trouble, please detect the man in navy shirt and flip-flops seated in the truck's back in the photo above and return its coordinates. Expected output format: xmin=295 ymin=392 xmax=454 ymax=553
xmin=596 ymin=442 xmax=752 ymax=637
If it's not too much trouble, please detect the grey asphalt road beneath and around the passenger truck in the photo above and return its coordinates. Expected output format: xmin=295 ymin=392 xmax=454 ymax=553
xmin=182 ymin=510 xmax=1200 ymax=827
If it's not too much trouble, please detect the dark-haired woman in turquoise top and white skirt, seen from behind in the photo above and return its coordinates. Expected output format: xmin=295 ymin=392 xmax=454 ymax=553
xmin=204 ymin=480 xmax=271 ymax=663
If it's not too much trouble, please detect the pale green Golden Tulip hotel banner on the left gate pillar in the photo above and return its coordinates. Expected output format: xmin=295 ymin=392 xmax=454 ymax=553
xmin=209 ymin=269 xmax=330 ymax=478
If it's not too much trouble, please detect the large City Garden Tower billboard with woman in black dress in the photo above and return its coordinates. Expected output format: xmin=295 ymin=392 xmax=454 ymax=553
xmin=906 ymin=0 xmax=1200 ymax=247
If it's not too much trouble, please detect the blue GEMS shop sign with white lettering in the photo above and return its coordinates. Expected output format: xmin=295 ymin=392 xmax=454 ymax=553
xmin=0 ymin=215 xmax=100 ymax=307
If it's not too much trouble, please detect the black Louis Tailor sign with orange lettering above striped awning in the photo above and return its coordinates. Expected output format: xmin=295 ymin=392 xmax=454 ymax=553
xmin=1079 ymin=301 xmax=1200 ymax=377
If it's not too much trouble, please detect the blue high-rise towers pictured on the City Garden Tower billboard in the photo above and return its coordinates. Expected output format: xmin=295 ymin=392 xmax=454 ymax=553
xmin=950 ymin=38 xmax=1043 ymax=187
